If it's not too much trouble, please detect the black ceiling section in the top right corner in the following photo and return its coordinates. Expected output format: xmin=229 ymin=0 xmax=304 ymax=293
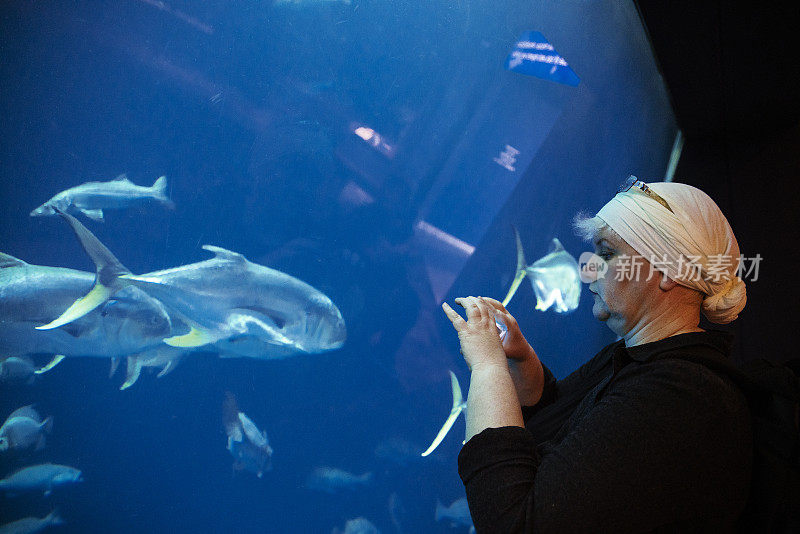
xmin=636 ymin=0 xmax=800 ymax=139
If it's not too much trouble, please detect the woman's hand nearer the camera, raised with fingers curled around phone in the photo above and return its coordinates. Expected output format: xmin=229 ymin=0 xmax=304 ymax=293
xmin=442 ymin=297 xmax=508 ymax=369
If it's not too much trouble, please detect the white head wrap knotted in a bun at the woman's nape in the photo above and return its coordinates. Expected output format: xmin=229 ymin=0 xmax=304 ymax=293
xmin=597 ymin=182 xmax=747 ymax=324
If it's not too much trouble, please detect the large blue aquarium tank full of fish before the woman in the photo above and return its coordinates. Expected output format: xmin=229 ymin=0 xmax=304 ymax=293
xmin=0 ymin=0 xmax=680 ymax=534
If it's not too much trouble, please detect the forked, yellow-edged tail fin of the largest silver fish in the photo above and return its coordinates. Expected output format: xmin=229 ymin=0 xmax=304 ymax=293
xmin=36 ymin=208 xmax=130 ymax=330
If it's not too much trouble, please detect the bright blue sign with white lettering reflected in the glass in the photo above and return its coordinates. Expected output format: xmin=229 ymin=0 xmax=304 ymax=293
xmin=505 ymin=32 xmax=580 ymax=87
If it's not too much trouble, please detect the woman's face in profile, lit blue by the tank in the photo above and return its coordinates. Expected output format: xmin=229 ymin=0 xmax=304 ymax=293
xmin=589 ymin=230 xmax=661 ymax=337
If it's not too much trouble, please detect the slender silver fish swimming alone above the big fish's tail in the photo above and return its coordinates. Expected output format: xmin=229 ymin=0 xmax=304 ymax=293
xmin=31 ymin=174 xmax=175 ymax=222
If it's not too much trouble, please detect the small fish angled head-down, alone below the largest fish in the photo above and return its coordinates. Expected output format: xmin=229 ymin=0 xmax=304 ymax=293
xmin=222 ymin=392 xmax=272 ymax=478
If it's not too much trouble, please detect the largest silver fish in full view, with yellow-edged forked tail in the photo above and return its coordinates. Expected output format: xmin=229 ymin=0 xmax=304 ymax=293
xmin=37 ymin=212 xmax=347 ymax=353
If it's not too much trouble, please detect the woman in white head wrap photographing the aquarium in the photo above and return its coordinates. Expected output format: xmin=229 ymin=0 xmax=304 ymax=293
xmin=443 ymin=181 xmax=752 ymax=533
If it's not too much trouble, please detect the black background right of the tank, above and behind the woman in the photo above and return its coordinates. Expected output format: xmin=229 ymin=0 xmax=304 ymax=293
xmin=637 ymin=0 xmax=800 ymax=361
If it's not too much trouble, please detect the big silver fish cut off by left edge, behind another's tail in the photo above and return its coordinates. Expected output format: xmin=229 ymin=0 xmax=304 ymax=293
xmin=0 ymin=253 xmax=172 ymax=360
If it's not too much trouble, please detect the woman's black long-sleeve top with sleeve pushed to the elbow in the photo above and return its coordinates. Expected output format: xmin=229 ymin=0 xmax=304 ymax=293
xmin=458 ymin=331 xmax=752 ymax=533
